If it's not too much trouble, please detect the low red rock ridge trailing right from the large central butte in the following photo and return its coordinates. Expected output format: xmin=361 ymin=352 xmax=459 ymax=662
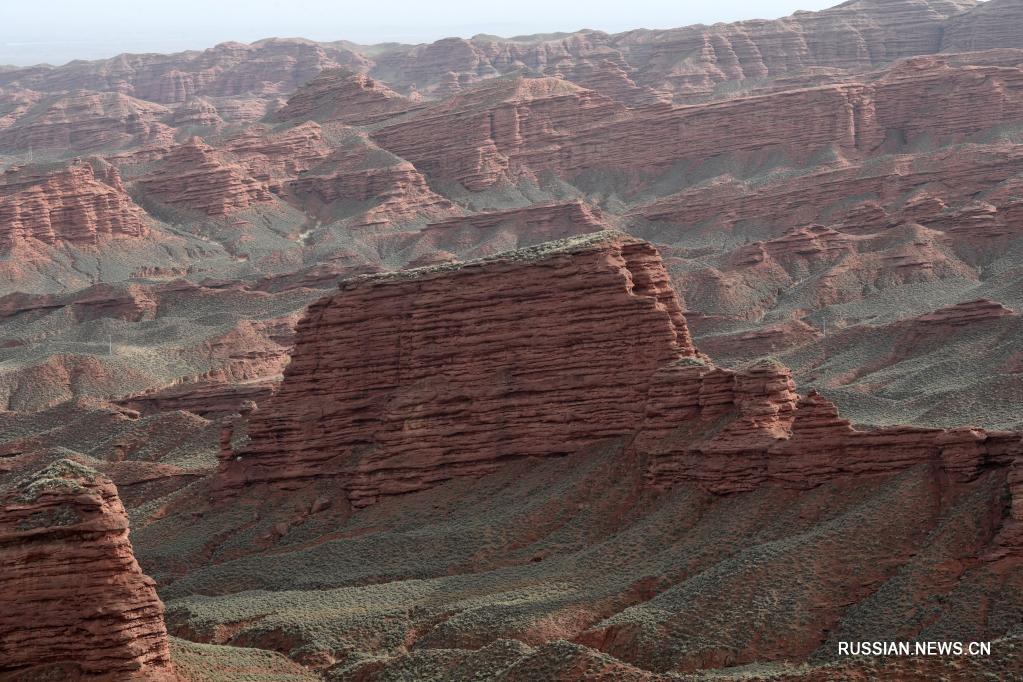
xmin=632 ymin=362 xmax=1023 ymax=493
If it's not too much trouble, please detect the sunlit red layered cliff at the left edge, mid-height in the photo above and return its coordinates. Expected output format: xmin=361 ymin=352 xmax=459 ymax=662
xmin=0 ymin=163 xmax=148 ymax=248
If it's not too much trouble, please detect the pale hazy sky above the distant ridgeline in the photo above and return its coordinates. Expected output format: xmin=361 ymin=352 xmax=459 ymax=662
xmin=0 ymin=0 xmax=841 ymax=64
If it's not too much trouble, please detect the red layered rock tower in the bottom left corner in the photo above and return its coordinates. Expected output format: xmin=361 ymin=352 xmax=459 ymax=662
xmin=0 ymin=459 xmax=178 ymax=682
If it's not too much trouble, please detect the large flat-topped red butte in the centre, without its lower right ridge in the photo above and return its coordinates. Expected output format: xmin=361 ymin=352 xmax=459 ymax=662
xmin=218 ymin=232 xmax=697 ymax=506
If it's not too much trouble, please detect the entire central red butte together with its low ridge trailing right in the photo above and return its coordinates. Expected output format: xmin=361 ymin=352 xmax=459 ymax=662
xmin=219 ymin=232 xmax=1021 ymax=506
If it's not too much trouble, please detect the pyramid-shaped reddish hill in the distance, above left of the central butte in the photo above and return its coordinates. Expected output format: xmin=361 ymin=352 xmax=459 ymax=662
xmin=273 ymin=70 xmax=415 ymax=126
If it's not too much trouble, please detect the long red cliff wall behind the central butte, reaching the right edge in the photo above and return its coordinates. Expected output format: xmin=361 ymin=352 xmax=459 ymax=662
xmin=373 ymin=57 xmax=1023 ymax=191
